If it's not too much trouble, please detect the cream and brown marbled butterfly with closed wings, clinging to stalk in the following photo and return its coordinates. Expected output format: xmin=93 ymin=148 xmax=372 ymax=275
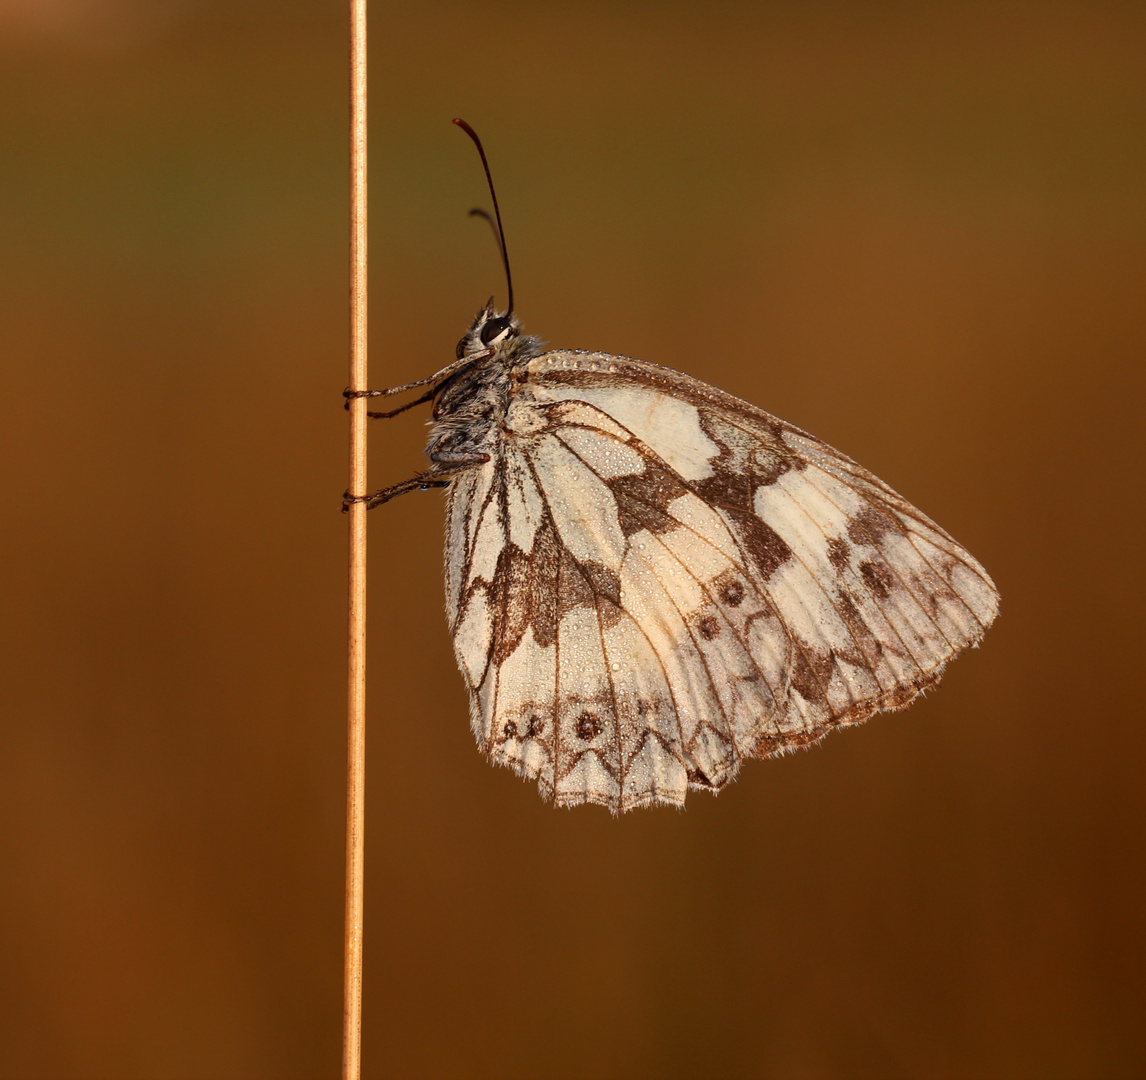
xmin=347 ymin=122 xmax=998 ymax=813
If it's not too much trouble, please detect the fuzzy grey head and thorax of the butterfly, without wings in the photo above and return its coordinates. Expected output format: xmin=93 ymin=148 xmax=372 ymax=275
xmin=426 ymin=300 xmax=542 ymax=464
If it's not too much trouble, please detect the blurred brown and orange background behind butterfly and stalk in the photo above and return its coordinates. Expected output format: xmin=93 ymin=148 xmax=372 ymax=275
xmin=0 ymin=0 xmax=1146 ymax=1080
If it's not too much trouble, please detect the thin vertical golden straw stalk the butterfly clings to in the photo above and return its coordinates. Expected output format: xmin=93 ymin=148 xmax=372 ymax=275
xmin=343 ymin=0 xmax=368 ymax=1080
